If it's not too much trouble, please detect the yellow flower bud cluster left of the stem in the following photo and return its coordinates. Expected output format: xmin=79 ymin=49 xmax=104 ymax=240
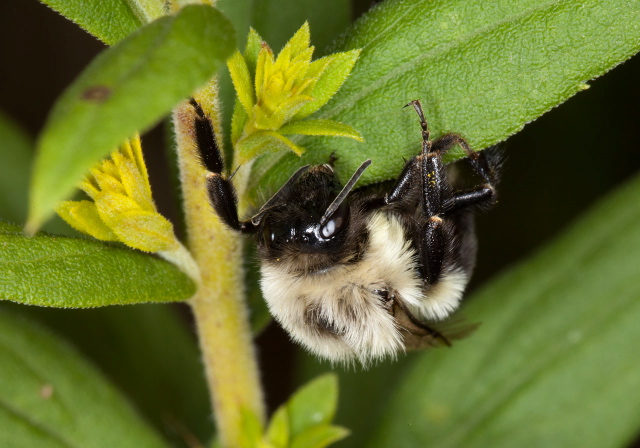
xmin=56 ymin=136 xmax=181 ymax=252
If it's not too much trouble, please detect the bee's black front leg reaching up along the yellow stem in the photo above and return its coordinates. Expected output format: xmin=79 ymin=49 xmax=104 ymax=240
xmin=190 ymin=98 xmax=255 ymax=233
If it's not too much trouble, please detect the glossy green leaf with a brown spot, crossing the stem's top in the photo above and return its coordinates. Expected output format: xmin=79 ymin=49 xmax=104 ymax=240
xmin=29 ymin=5 xmax=235 ymax=231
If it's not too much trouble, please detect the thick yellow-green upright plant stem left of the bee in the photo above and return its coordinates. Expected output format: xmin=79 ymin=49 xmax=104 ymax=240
xmin=173 ymin=93 xmax=265 ymax=447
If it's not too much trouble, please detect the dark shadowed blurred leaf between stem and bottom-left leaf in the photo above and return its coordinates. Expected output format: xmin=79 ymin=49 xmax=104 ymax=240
xmin=8 ymin=302 xmax=213 ymax=447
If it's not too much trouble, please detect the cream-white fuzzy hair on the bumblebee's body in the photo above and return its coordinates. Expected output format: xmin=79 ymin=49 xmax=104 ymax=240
xmin=260 ymin=212 xmax=466 ymax=366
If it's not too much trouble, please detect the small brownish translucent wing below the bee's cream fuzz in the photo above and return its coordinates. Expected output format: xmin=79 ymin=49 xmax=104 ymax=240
xmin=393 ymin=300 xmax=480 ymax=350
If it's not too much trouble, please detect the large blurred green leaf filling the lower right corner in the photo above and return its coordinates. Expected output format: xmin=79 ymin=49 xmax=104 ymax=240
xmin=367 ymin=172 xmax=640 ymax=448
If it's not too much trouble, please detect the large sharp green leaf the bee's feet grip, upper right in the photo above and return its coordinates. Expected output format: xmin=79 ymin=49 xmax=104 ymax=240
xmin=249 ymin=0 xmax=640 ymax=201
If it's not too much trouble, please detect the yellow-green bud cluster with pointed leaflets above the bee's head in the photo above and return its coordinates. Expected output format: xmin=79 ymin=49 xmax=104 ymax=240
xmin=227 ymin=23 xmax=363 ymax=164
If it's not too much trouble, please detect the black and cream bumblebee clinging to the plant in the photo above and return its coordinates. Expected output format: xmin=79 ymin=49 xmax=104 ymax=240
xmin=191 ymin=100 xmax=500 ymax=365
